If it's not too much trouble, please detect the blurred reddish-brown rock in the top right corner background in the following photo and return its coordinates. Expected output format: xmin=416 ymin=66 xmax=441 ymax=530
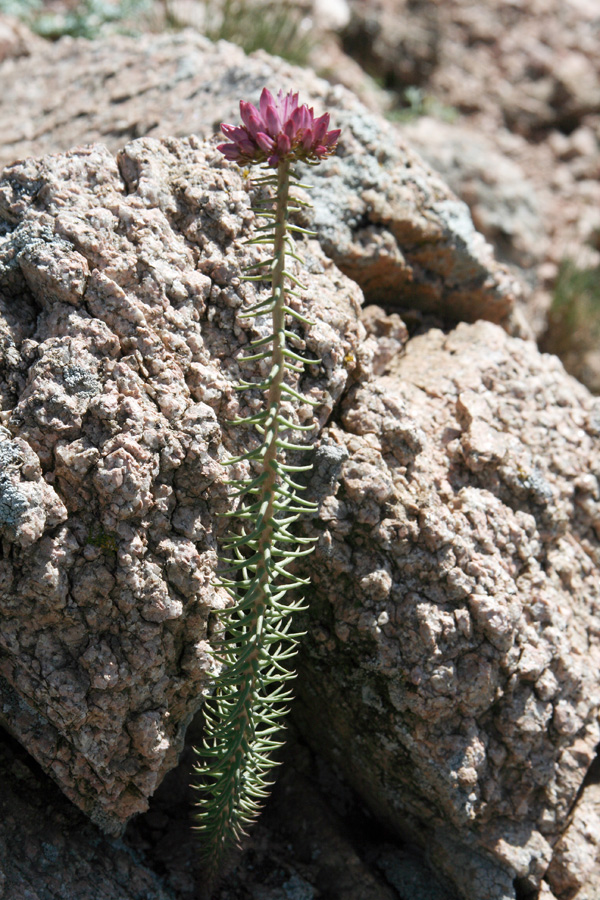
xmin=344 ymin=0 xmax=600 ymax=136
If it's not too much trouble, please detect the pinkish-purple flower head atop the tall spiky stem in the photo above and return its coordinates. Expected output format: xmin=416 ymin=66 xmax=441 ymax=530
xmin=218 ymin=88 xmax=340 ymax=169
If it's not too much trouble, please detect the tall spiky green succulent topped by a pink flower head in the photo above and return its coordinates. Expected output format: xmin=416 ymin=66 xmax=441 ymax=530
xmin=196 ymin=88 xmax=340 ymax=872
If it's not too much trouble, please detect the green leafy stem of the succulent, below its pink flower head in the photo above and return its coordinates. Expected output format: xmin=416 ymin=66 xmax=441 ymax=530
xmin=197 ymin=162 xmax=296 ymax=874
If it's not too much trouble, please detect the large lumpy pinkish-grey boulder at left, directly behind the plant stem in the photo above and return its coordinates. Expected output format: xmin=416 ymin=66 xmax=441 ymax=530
xmin=0 ymin=139 xmax=364 ymax=833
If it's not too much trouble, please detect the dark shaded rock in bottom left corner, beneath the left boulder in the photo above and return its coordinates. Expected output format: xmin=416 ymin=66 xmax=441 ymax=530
xmin=0 ymin=732 xmax=176 ymax=900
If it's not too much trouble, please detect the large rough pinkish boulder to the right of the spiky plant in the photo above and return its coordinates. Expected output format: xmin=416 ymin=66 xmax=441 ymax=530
xmin=296 ymin=315 xmax=600 ymax=900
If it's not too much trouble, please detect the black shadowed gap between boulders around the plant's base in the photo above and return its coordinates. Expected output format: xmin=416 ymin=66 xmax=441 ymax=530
xmin=124 ymin=715 xmax=454 ymax=900
